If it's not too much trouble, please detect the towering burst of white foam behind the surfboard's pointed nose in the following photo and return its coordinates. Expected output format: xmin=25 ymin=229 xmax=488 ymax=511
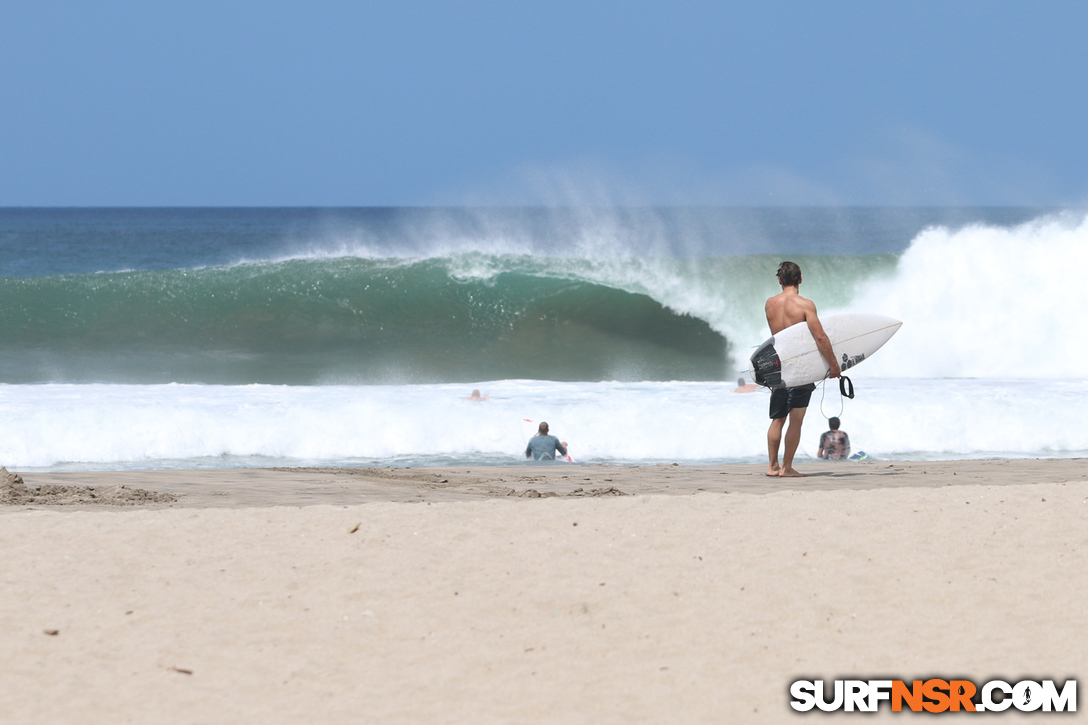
xmin=845 ymin=216 xmax=1088 ymax=380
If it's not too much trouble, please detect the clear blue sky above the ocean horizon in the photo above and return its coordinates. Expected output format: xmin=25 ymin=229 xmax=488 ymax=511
xmin=0 ymin=0 xmax=1088 ymax=206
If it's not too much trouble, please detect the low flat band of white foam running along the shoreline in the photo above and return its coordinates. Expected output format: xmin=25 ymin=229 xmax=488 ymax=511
xmin=0 ymin=380 xmax=1088 ymax=469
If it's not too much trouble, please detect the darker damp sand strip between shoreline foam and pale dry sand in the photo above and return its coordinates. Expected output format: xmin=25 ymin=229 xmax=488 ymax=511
xmin=10 ymin=458 xmax=1088 ymax=508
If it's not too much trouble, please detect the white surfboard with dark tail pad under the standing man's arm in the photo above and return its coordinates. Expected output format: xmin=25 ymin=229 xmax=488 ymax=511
xmin=749 ymin=315 xmax=903 ymax=388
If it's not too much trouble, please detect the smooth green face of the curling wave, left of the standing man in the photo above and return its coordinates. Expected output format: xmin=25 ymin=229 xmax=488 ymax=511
xmin=0 ymin=258 xmax=730 ymax=384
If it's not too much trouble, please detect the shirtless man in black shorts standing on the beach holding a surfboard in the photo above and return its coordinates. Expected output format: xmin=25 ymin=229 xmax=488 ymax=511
xmin=764 ymin=261 xmax=842 ymax=478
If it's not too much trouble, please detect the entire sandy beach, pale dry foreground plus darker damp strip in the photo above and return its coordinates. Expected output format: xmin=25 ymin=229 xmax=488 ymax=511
xmin=0 ymin=459 xmax=1088 ymax=724
